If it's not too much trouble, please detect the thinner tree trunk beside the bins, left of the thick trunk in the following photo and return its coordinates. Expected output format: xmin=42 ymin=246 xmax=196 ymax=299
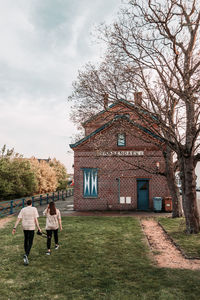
xmin=164 ymin=147 xmax=183 ymax=218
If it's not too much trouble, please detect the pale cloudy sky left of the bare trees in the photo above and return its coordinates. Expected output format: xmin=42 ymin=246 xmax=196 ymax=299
xmin=0 ymin=0 xmax=121 ymax=172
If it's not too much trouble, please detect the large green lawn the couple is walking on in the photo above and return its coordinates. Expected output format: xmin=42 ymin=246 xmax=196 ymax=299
xmin=0 ymin=217 xmax=200 ymax=300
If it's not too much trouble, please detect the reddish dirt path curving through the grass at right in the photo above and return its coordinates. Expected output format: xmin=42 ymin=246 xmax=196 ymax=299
xmin=141 ymin=219 xmax=200 ymax=270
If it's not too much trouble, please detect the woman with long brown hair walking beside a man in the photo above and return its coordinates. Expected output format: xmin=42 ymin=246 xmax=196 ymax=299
xmin=43 ymin=202 xmax=62 ymax=255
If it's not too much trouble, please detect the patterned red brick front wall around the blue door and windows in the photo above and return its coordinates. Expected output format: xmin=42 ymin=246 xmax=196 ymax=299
xmin=74 ymin=121 xmax=169 ymax=210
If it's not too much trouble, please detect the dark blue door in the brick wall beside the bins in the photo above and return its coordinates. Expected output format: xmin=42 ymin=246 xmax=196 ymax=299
xmin=137 ymin=179 xmax=149 ymax=210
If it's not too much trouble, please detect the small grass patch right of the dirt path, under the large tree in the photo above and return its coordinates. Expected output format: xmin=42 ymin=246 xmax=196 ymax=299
xmin=159 ymin=218 xmax=200 ymax=258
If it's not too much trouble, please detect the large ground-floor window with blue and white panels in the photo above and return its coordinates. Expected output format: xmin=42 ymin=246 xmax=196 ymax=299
xmin=83 ymin=168 xmax=98 ymax=198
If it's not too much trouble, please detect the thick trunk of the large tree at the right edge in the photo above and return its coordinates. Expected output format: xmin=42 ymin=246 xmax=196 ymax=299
xmin=179 ymin=156 xmax=200 ymax=234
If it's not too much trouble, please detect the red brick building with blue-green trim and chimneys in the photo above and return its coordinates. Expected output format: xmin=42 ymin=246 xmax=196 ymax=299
xmin=70 ymin=94 xmax=169 ymax=211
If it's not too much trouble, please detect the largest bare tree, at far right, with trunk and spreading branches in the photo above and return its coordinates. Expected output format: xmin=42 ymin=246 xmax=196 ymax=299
xmin=96 ymin=0 xmax=200 ymax=233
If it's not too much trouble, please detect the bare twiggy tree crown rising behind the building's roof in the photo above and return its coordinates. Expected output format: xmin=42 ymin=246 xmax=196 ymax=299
xmin=69 ymin=53 xmax=136 ymax=124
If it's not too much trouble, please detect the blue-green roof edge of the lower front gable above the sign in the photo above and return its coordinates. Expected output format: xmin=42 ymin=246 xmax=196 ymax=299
xmin=69 ymin=115 xmax=163 ymax=149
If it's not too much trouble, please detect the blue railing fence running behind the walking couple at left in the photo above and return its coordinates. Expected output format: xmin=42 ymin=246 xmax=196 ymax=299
xmin=0 ymin=188 xmax=74 ymax=218
